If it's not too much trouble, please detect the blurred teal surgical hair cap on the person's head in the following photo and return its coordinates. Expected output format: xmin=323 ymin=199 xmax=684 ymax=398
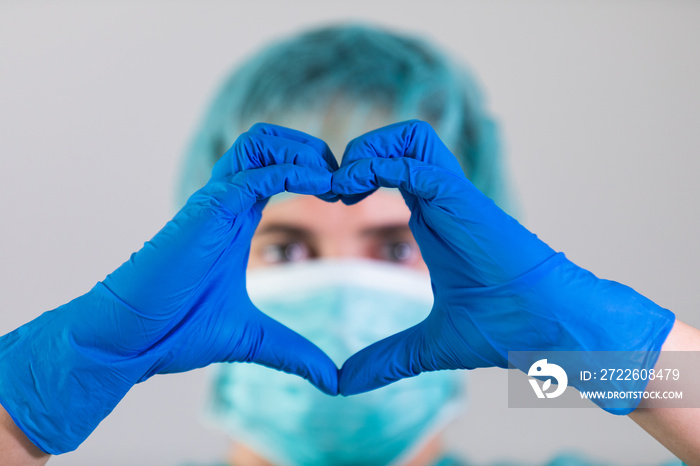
xmin=178 ymin=25 xmax=510 ymax=210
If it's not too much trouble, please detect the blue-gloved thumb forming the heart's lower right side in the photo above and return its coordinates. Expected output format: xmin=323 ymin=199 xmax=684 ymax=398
xmin=338 ymin=323 xmax=425 ymax=396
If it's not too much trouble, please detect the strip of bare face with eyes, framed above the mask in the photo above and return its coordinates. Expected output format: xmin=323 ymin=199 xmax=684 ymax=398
xmin=248 ymin=190 xmax=428 ymax=272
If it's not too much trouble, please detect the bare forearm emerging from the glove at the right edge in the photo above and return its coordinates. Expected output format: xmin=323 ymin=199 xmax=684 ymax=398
xmin=629 ymin=320 xmax=700 ymax=464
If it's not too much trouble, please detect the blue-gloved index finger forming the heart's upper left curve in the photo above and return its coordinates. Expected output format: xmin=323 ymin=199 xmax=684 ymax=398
xmin=211 ymin=163 xmax=332 ymax=214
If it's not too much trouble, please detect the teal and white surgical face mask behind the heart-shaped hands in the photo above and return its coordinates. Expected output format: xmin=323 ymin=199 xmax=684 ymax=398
xmin=208 ymin=260 xmax=465 ymax=466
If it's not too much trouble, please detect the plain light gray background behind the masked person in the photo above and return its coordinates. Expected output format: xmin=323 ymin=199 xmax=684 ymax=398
xmin=0 ymin=0 xmax=700 ymax=465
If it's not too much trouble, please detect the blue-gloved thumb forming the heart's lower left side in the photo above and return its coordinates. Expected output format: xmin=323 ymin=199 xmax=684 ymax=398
xmin=251 ymin=313 xmax=338 ymax=395
